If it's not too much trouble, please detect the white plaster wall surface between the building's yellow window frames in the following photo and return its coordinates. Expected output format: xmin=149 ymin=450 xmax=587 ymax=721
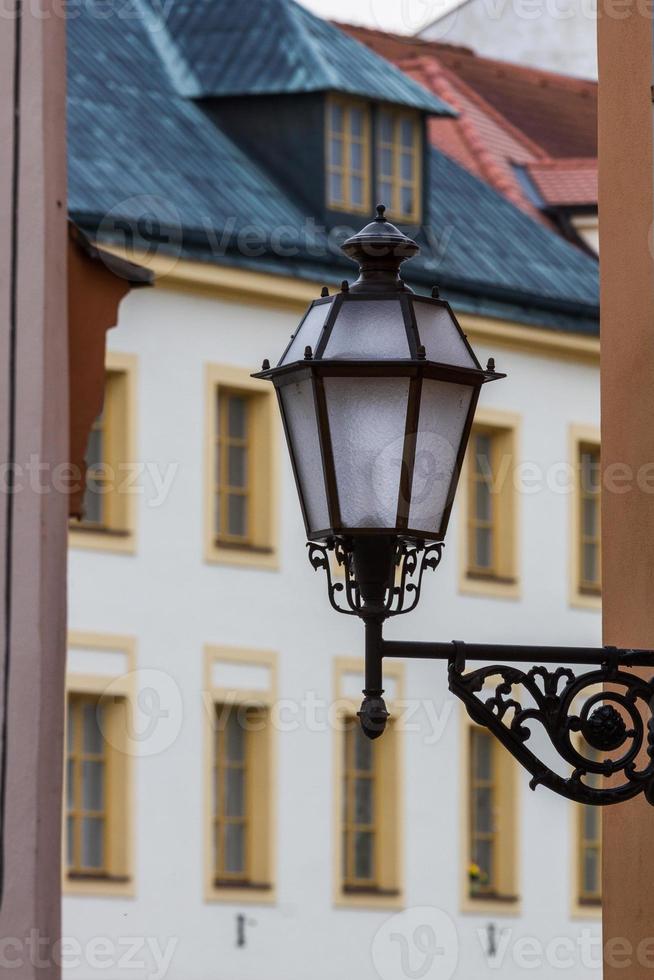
xmin=64 ymin=289 xmax=600 ymax=980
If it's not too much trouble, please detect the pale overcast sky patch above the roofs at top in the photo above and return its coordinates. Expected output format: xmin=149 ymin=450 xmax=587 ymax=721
xmin=300 ymin=0 xmax=454 ymax=34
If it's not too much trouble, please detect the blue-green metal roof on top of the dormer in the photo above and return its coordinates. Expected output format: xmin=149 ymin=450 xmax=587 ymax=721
xmin=131 ymin=0 xmax=453 ymax=115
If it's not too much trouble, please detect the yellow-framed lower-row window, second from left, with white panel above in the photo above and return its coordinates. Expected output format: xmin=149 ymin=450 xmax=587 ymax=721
xmin=205 ymin=647 xmax=275 ymax=903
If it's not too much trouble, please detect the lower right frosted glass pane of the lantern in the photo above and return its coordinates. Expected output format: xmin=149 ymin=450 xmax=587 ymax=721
xmin=409 ymin=379 xmax=474 ymax=534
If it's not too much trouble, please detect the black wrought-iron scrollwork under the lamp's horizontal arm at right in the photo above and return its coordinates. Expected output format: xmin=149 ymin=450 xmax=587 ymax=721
xmin=449 ymin=657 xmax=654 ymax=806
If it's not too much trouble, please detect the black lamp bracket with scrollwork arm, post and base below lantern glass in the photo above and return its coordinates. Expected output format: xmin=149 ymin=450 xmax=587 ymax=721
xmin=308 ymin=537 xmax=654 ymax=806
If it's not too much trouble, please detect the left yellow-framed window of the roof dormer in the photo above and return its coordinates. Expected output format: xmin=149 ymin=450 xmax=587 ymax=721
xmin=327 ymin=99 xmax=371 ymax=214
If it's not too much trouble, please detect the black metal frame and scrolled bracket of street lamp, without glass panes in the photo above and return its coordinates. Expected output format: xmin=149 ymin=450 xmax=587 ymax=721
xmin=254 ymin=212 xmax=654 ymax=806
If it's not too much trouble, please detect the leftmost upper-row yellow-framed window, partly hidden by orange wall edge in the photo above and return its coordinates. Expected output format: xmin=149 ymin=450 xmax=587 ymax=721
xmin=71 ymin=352 xmax=136 ymax=551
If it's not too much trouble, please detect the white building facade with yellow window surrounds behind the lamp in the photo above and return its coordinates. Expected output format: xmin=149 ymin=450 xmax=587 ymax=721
xmin=64 ymin=268 xmax=601 ymax=980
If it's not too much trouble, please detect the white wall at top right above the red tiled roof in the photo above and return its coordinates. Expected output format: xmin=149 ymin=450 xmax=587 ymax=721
xmin=420 ymin=0 xmax=597 ymax=78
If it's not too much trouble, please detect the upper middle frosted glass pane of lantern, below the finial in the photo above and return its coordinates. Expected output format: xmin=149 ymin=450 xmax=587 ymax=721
xmin=323 ymin=300 xmax=411 ymax=361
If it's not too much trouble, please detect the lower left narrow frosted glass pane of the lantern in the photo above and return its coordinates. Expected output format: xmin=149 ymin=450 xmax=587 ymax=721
xmin=280 ymin=378 xmax=329 ymax=533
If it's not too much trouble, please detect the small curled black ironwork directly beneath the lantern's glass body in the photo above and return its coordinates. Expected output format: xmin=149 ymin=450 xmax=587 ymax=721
xmin=307 ymin=538 xmax=443 ymax=618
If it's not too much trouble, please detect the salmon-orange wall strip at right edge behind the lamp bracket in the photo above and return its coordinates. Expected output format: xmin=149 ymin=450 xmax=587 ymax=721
xmin=599 ymin=0 xmax=654 ymax=980
